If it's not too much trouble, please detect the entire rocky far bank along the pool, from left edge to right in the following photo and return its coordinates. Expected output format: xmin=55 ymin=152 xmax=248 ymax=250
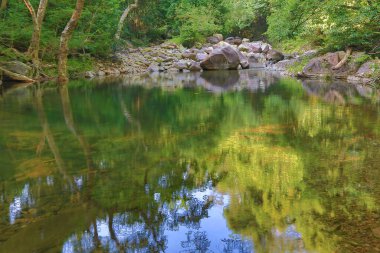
xmin=0 ymin=34 xmax=380 ymax=87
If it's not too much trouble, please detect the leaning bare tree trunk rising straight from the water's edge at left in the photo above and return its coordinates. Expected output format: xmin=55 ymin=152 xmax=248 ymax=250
xmin=58 ymin=0 xmax=85 ymax=83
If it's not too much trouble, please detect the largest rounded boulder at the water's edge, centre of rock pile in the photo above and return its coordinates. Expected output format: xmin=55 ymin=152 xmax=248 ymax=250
xmin=200 ymin=46 xmax=240 ymax=70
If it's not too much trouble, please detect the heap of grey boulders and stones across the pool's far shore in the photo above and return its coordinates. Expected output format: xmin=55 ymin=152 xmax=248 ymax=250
xmin=90 ymin=34 xmax=284 ymax=77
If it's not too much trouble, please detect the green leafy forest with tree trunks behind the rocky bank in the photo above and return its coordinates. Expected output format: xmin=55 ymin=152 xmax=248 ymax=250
xmin=0 ymin=0 xmax=380 ymax=83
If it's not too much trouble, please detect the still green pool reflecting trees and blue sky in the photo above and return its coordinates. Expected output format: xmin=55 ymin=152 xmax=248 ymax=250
xmin=0 ymin=71 xmax=380 ymax=253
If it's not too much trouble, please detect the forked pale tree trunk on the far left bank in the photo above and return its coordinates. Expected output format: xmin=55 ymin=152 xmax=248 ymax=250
xmin=24 ymin=0 xmax=48 ymax=67
